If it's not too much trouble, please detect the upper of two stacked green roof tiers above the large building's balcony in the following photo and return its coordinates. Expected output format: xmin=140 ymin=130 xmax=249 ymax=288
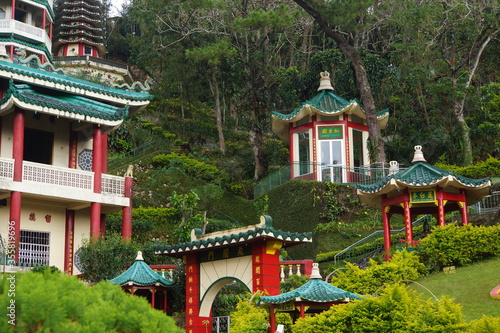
xmin=0 ymin=61 xmax=153 ymax=101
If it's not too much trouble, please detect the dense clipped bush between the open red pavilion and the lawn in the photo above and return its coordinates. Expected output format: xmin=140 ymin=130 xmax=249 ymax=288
xmin=419 ymin=224 xmax=500 ymax=267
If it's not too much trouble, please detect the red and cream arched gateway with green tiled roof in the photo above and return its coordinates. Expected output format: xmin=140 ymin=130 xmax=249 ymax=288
xmin=155 ymin=216 xmax=312 ymax=333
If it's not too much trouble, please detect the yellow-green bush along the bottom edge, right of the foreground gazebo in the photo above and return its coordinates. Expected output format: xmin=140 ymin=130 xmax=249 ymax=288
xmin=292 ymin=285 xmax=467 ymax=333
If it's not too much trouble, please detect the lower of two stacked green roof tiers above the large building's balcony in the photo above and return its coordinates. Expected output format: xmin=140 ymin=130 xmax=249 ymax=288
xmin=0 ymin=80 xmax=128 ymax=121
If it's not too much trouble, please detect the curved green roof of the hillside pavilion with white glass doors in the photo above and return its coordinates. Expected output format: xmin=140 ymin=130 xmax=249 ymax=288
xmin=272 ymin=72 xmax=389 ymax=141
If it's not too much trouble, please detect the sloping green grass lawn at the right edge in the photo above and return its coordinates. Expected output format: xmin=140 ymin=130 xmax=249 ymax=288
xmin=410 ymin=258 xmax=500 ymax=322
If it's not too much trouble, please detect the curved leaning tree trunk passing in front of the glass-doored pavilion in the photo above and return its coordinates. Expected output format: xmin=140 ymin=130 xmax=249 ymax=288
xmin=294 ymin=0 xmax=385 ymax=163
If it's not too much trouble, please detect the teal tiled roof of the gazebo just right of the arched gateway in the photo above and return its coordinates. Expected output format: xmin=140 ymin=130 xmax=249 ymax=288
xmin=259 ymin=279 xmax=361 ymax=304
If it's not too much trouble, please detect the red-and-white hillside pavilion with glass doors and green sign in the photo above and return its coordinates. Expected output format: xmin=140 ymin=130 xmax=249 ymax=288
xmin=272 ymin=72 xmax=389 ymax=183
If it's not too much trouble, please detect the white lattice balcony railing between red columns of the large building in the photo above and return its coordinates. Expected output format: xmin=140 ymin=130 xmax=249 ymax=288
xmin=0 ymin=158 xmax=125 ymax=197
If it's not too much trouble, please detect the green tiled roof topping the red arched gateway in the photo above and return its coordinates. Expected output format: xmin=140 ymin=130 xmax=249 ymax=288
xmin=155 ymin=225 xmax=312 ymax=255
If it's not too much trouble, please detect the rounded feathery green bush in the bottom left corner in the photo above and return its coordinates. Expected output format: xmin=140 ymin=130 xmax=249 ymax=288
xmin=0 ymin=270 xmax=183 ymax=333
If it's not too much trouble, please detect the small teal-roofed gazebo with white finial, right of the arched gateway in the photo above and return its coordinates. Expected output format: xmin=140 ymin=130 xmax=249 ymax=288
xmin=258 ymin=263 xmax=361 ymax=332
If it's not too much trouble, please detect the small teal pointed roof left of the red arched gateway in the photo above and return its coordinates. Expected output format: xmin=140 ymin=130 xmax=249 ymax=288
xmin=108 ymin=251 xmax=174 ymax=288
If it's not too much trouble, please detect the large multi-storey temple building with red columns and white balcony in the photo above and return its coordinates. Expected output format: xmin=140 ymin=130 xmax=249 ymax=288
xmin=0 ymin=0 xmax=152 ymax=274
